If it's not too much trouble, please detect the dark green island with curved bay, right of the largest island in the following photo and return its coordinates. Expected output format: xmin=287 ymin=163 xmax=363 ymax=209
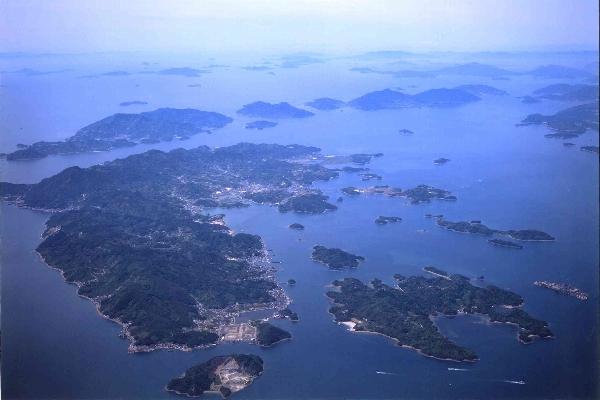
xmin=327 ymin=268 xmax=552 ymax=361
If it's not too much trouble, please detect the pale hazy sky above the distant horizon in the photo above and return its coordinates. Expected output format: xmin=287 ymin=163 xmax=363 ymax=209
xmin=0 ymin=0 xmax=598 ymax=52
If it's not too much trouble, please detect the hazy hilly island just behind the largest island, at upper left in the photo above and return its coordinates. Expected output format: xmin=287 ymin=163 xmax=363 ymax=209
xmin=6 ymin=108 xmax=233 ymax=160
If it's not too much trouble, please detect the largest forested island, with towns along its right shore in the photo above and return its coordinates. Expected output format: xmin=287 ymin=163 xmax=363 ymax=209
xmin=0 ymin=143 xmax=338 ymax=351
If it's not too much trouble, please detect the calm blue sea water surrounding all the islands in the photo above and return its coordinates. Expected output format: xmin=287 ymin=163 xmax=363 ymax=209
xmin=0 ymin=52 xmax=599 ymax=399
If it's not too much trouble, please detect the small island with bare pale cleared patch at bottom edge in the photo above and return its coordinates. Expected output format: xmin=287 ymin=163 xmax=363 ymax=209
xmin=166 ymin=354 xmax=263 ymax=398
